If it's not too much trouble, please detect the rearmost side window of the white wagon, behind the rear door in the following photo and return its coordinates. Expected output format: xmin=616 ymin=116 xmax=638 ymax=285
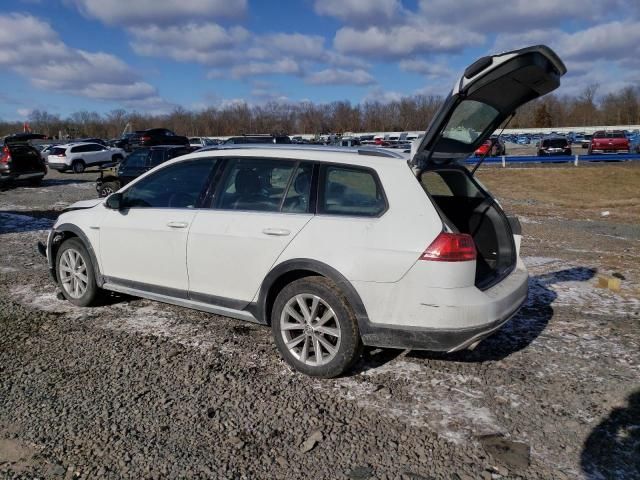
xmin=320 ymin=166 xmax=386 ymax=217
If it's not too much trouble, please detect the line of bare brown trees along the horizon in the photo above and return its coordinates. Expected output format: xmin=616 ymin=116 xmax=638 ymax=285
xmin=0 ymin=85 xmax=640 ymax=138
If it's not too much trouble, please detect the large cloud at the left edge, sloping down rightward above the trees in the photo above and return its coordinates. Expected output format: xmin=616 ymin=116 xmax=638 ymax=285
xmin=0 ymin=14 xmax=157 ymax=100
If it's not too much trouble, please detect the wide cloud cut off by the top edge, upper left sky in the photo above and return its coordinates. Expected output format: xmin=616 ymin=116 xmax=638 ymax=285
xmin=67 ymin=0 xmax=247 ymax=26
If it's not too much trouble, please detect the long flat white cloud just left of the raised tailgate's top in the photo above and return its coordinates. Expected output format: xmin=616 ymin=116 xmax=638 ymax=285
xmin=333 ymin=25 xmax=484 ymax=58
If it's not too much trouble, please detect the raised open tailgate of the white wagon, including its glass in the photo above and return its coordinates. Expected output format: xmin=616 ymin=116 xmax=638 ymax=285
xmin=412 ymin=46 xmax=567 ymax=169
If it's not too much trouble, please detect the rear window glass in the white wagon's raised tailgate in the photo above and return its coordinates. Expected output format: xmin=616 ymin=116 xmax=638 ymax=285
xmin=442 ymin=100 xmax=498 ymax=145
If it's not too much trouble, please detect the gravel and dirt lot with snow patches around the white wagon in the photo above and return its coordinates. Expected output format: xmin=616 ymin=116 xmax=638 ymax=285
xmin=0 ymin=164 xmax=640 ymax=480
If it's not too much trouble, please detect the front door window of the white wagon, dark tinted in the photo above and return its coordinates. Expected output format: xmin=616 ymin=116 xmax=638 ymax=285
xmin=124 ymin=159 xmax=216 ymax=208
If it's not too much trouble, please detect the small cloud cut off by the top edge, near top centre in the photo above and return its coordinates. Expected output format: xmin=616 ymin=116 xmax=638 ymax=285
xmin=314 ymin=0 xmax=405 ymax=25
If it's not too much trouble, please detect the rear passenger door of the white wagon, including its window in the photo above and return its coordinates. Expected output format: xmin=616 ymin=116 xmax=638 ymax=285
xmin=187 ymin=158 xmax=313 ymax=309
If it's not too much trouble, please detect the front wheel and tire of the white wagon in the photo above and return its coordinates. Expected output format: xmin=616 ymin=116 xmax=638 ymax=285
xmin=56 ymin=237 xmax=100 ymax=307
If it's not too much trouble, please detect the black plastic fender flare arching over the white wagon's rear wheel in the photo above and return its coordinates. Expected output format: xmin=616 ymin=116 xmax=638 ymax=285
xmin=248 ymin=258 xmax=369 ymax=333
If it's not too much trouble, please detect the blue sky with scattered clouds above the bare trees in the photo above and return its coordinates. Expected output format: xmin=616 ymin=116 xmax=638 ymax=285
xmin=0 ymin=0 xmax=640 ymax=121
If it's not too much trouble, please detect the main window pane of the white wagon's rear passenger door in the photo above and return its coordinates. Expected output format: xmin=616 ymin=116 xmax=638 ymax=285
xmin=216 ymin=159 xmax=296 ymax=212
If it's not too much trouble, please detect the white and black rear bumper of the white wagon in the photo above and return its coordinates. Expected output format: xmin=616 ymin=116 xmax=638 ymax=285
xmin=360 ymin=264 xmax=529 ymax=352
